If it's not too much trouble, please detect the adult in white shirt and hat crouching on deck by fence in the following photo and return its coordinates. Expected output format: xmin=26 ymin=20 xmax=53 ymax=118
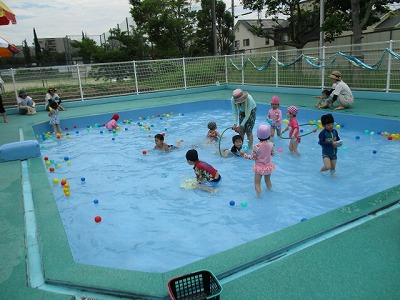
xmin=329 ymin=71 xmax=354 ymax=110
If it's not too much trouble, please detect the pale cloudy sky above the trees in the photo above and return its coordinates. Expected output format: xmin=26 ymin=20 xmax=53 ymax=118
xmin=0 ymin=0 xmax=257 ymax=46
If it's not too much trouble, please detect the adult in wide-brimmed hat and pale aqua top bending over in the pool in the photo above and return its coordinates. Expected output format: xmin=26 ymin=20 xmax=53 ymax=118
xmin=231 ymin=89 xmax=257 ymax=149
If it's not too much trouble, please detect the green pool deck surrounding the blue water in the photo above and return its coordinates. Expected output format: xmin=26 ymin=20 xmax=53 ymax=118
xmin=0 ymin=86 xmax=400 ymax=300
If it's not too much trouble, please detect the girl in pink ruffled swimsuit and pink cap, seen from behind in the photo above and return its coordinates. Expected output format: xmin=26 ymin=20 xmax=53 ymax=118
xmin=242 ymin=125 xmax=275 ymax=198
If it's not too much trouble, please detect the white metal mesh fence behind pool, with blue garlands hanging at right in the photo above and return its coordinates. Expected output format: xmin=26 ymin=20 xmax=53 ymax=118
xmin=0 ymin=41 xmax=400 ymax=106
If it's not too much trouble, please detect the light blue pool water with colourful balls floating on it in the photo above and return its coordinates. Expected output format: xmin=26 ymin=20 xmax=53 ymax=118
xmin=41 ymin=109 xmax=400 ymax=272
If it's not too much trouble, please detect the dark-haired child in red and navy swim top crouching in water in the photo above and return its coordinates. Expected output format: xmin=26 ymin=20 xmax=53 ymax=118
xmin=186 ymin=149 xmax=221 ymax=193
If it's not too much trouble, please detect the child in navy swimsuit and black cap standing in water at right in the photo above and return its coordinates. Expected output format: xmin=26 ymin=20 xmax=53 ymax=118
xmin=318 ymin=114 xmax=342 ymax=174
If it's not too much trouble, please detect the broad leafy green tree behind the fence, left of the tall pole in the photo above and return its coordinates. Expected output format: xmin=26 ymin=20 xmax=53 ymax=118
xmin=129 ymin=0 xmax=196 ymax=58
